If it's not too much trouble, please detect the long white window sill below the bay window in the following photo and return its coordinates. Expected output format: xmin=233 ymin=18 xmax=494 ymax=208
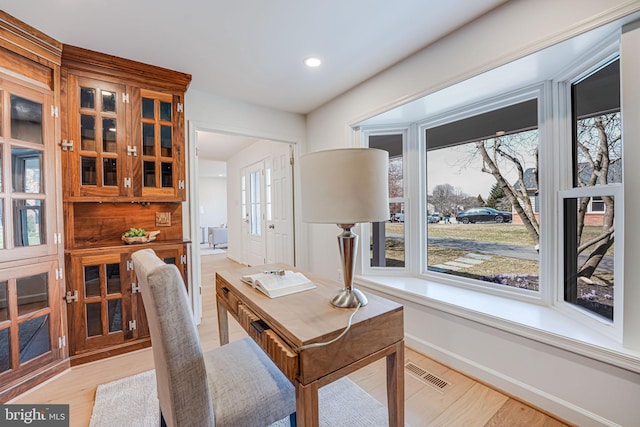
xmin=356 ymin=276 xmax=640 ymax=373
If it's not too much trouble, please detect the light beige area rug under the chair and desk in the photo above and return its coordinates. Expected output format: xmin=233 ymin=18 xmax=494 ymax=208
xmin=90 ymin=371 xmax=396 ymax=427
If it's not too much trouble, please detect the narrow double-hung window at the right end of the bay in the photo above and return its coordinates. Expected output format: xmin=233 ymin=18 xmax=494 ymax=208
xmin=560 ymin=56 xmax=624 ymax=337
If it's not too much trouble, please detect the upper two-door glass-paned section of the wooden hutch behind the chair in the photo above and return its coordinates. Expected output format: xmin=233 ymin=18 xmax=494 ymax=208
xmin=62 ymin=45 xmax=191 ymax=202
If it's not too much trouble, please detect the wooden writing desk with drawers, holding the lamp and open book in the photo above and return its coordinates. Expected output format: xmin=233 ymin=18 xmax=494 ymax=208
xmin=216 ymin=264 xmax=404 ymax=427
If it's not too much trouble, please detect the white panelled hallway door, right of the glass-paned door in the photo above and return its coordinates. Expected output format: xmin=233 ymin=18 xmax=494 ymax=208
xmin=265 ymin=144 xmax=295 ymax=265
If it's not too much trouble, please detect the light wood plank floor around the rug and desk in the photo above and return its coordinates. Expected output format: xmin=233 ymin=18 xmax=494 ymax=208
xmin=12 ymin=254 xmax=567 ymax=427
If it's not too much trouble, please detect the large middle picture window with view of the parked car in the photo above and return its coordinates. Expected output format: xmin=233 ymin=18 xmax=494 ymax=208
xmin=420 ymin=90 xmax=541 ymax=296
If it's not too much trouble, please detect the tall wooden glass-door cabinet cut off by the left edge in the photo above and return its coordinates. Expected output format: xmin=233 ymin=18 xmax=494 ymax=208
xmin=0 ymin=11 xmax=69 ymax=403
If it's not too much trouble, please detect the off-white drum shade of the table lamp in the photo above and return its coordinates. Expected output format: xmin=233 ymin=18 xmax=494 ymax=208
xmin=300 ymin=148 xmax=389 ymax=224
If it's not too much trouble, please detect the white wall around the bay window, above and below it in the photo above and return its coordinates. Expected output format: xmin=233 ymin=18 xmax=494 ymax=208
xmin=306 ymin=0 xmax=640 ymax=426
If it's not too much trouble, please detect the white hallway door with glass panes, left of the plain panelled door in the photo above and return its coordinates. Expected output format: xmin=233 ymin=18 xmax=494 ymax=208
xmin=243 ymin=161 xmax=266 ymax=265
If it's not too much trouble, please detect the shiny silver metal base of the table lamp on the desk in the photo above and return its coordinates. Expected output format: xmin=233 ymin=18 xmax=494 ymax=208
xmin=331 ymin=224 xmax=369 ymax=308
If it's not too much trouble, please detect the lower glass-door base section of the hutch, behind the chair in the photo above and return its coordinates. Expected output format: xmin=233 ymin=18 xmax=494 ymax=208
xmin=65 ymin=244 xmax=188 ymax=365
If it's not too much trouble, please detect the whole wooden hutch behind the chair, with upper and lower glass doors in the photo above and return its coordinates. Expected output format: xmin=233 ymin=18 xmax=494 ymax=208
xmin=61 ymin=45 xmax=191 ymax=365
